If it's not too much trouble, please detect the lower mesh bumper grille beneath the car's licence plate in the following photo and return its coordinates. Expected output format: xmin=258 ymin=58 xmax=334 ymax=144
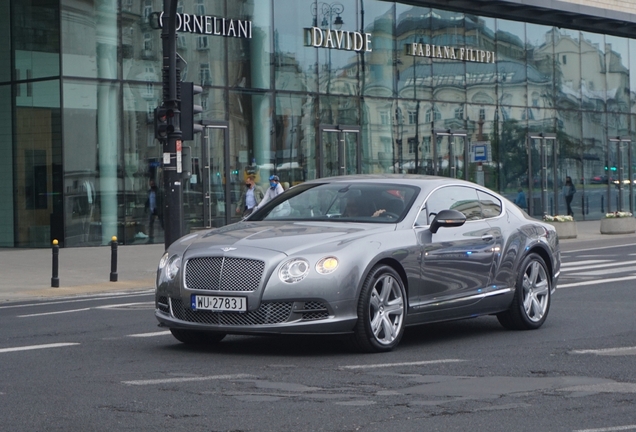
xmin=170 ymin=298 xmax=292 ymax=326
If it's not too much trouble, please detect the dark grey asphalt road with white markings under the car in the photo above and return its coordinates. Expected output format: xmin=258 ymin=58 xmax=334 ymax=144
xmin=0 ymin=244 xmax=636 ymax=432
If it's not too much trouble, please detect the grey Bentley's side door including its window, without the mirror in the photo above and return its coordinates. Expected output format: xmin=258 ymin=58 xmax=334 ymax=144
xmin=412 ymin=185 xmax=496 ymax=314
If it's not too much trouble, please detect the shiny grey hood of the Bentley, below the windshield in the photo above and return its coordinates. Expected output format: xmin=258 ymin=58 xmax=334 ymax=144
xmin=181 ymin=222 xmax=395 ymax=255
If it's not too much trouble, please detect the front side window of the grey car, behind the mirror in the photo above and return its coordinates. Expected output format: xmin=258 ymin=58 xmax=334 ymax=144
xmin=418 ymin=186 xmax=482 ymax=225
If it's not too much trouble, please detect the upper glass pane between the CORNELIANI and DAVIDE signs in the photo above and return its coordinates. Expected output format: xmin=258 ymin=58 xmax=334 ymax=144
xmin=274 ymin=0 xmax=319 ymax=92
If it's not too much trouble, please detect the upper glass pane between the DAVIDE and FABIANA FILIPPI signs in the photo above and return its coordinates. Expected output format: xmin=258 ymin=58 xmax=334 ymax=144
xmin=359 ymin=0 xmax=395 ymax=97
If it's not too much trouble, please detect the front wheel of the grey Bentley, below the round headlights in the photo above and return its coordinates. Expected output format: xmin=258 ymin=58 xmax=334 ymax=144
xmin=353 ymin=265 xmax=406 ymax=352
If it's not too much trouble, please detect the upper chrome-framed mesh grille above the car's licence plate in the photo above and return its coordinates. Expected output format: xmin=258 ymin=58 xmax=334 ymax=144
xmin=185 ymin=257 xmax=265 ymax=291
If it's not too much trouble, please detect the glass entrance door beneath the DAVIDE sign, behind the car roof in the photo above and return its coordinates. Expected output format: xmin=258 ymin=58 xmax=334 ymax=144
xmin=318 ymin=125 xmax=362 ymax=177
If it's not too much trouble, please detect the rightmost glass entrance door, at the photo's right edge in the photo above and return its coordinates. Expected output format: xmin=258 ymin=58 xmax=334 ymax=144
xmin=607 ymin=136 xmax=634 ymax=212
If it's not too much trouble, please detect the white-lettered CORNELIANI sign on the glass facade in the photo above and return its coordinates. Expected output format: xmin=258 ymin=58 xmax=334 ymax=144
xmin=159 ymin=12 xmax=252 ymax=39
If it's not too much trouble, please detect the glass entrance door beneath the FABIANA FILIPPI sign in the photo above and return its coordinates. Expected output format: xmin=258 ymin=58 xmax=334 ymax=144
xmin=433 ymin=129 xmax=468 ymax=180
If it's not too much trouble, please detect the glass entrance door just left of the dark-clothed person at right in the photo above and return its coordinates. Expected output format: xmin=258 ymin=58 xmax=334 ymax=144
xmin=528 ymin=133 xmax=556 ymax=216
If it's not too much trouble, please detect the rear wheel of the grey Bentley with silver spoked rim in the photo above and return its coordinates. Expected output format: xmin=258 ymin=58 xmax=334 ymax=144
xmin=497 ymin=253 xmax=552 ymax=330
